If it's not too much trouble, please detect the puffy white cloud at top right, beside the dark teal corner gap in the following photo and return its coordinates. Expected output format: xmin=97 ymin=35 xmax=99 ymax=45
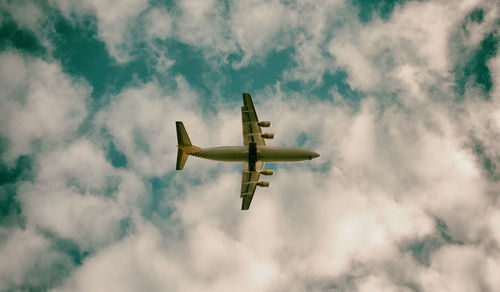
xmin=328 ymin=1 xmax=482 ymax=91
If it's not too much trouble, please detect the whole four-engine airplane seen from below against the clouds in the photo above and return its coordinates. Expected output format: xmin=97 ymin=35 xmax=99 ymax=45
xmin=175 ymin=93 xmax=319 ymax=210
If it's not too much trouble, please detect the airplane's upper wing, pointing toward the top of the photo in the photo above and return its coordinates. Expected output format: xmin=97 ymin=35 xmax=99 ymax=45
xmin=241 ymin=93 xmax=266 ymax=146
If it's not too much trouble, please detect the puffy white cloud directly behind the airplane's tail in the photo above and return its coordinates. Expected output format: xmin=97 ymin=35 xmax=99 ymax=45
xmin=97 ymin=77 xmax=211 ymax=176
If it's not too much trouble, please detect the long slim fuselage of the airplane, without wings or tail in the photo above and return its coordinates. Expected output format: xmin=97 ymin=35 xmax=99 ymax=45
xmin=190 ymin=146 xmax=319 ymax=162
